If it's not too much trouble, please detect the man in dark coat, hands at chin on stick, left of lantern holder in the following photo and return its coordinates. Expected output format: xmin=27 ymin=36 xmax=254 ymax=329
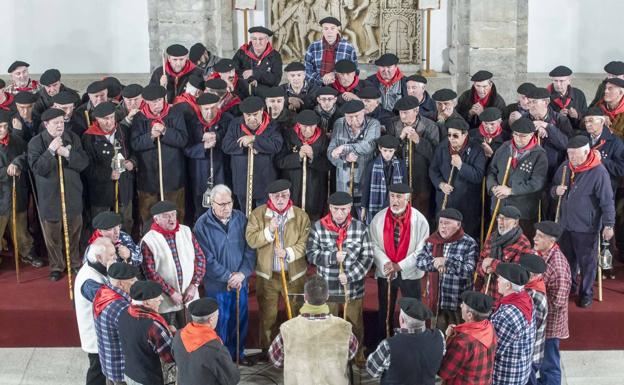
xmin=28 ymin=108 xmax=89 ymax=281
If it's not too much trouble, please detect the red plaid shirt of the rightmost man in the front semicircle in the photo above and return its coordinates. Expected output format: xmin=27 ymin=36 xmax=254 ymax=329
xmin=540 ymin=244 xmax=572 ymax=339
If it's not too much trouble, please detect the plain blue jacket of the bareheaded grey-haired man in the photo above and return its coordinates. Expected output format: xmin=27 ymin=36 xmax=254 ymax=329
xmin=193 ymin=209 xmax=256 ymax=296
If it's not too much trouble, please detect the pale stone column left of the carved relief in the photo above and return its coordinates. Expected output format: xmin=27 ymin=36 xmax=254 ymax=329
xmin=147 ymin=0 xmax=234 ymax=71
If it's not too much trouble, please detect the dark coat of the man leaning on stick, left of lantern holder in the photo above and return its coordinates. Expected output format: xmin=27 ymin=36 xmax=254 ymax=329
xmin=28 ymin=130 xmax=89 ymax=222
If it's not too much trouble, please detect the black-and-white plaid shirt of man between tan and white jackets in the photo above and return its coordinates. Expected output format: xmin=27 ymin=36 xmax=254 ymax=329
xmin=306 ymin=219 xmax=373 ymax=299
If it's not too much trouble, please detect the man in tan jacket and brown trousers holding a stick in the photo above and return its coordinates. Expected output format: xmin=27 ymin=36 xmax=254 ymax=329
xmin=245 ymin=179 xmax=310 ymax=349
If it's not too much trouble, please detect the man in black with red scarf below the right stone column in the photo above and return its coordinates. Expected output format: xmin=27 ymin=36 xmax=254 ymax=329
xmin=457 ymin=70 xmax=505 ymax=128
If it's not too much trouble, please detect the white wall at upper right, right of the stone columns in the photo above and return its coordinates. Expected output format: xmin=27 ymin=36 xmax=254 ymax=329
xmin=528 ymin=0 xmax=624 ymax=73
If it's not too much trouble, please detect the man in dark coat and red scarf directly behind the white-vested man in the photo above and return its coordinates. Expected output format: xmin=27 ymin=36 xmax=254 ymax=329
xmin=130 ymin=84 xmax=188 ymax=223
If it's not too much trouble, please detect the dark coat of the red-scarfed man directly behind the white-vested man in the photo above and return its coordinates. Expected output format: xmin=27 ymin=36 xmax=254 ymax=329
xmin=130 ymin=109 xmax=188 ymax=193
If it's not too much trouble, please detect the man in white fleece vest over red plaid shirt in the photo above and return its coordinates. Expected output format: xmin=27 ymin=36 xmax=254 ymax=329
xmin=141 ymin=201 xmax=206 ymax=327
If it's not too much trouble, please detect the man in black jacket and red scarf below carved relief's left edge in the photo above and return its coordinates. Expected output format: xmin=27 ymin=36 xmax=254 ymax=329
xmin=232 ymin=26 xmax=282 ymax=87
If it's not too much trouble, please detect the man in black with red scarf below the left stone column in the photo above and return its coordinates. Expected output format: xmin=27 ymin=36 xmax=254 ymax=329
xmin=150 ymin=44 xmax=202 ymax=103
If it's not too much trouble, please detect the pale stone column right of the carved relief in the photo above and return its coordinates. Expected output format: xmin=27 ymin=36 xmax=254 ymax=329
xmin=449 ymin=0 xmax=529 ymax=104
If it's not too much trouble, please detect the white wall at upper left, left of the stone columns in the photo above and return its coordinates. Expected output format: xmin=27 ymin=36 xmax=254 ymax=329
xmin=0 ymin=0 xmax=149 ymax=73
